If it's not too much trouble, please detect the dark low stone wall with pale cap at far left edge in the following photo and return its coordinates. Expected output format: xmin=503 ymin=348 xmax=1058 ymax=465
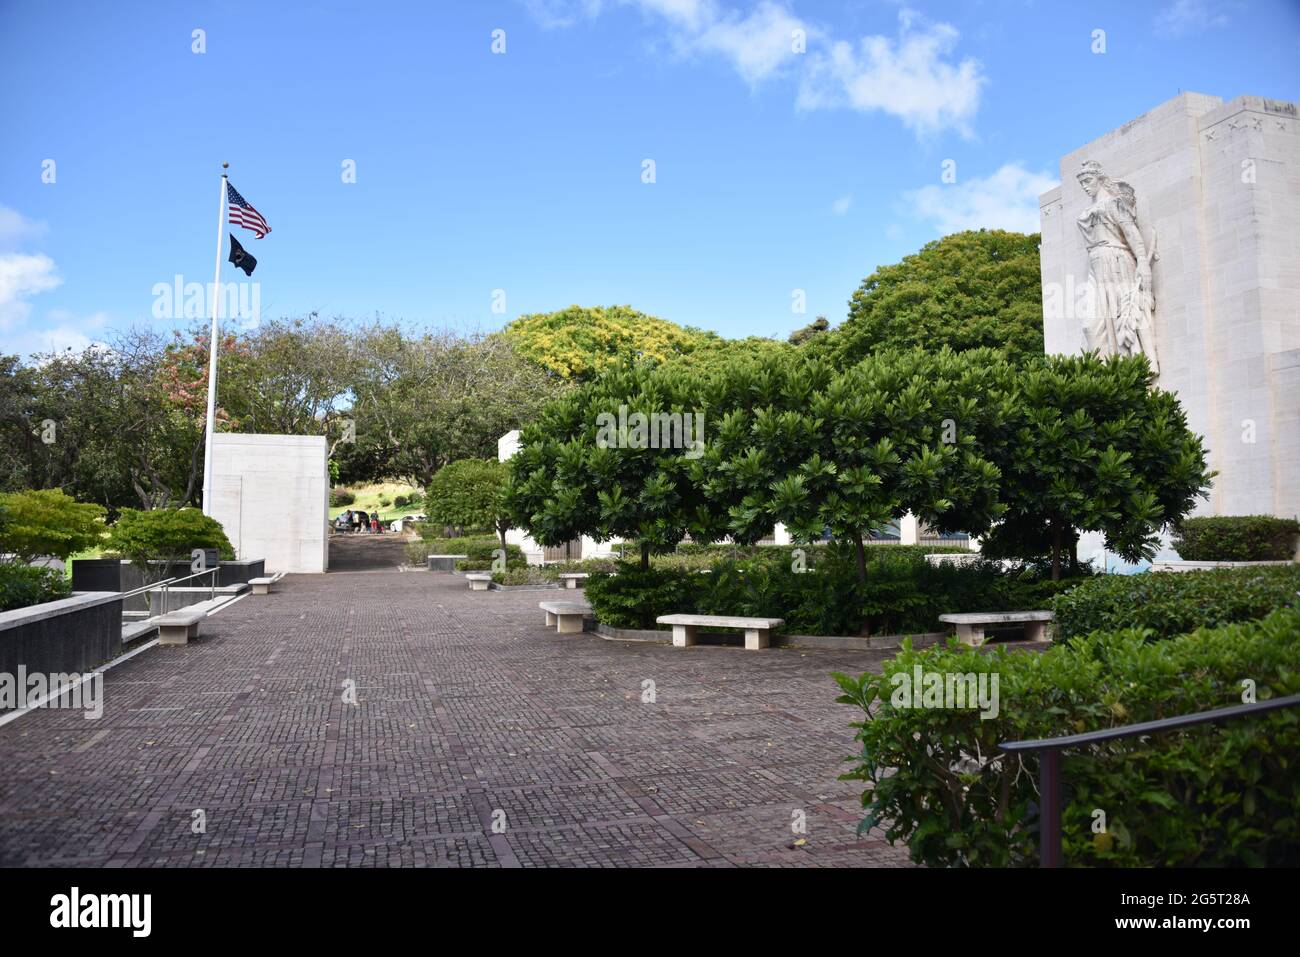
xmin=0 ymin=592 xmax=122 ymax=707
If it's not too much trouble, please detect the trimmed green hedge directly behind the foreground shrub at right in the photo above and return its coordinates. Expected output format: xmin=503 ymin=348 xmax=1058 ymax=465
xmin=1052 ymin=564 xmax=1300 ymax=641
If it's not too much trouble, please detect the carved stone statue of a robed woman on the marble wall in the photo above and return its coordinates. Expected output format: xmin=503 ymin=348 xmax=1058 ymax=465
xmin=1076 ymin=160 xmax=1160 ymax=376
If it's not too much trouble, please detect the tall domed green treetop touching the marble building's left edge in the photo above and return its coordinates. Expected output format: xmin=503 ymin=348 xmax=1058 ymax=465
xmin=811 ymin=229 xmax=1043 ymax=368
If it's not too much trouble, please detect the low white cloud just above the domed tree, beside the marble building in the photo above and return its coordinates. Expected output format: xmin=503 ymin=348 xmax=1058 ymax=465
xmin=904 ymin=163 xmax=1057 ymax=235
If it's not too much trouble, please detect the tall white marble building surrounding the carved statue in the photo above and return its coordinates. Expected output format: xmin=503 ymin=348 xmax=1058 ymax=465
xmin=1040 ymin=92 xmax=1300 ymax=546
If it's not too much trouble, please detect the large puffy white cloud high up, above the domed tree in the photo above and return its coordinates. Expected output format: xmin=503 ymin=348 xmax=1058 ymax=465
xmin=798 ymin=9 xmax=988 ymax=135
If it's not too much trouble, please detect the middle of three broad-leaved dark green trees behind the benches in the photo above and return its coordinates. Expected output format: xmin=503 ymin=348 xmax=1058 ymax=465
xmin=699 ymin=350 xmax=1010 ymax=580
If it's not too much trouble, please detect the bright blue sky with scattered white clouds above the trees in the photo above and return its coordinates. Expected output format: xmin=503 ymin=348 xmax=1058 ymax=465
xmin=0 ymin=0 xmax=1300 ymax=354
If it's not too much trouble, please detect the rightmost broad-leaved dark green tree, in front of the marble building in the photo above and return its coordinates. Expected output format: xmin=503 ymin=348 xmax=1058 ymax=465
xmin=983 ymin=355 xmax=1213 ymax=579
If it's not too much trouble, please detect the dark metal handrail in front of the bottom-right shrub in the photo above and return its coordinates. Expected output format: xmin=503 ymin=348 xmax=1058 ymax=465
xmin=998 ymin=694 xmax=1300 ymax=867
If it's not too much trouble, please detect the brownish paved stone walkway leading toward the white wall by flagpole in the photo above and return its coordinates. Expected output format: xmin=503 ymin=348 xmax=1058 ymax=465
xmin=0 ymin=541 xmax=906 ymax=867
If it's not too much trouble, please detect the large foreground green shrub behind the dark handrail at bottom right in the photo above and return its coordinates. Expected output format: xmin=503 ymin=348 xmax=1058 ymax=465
xmin=835 ymin=608 xmax=1300 ymax=867
